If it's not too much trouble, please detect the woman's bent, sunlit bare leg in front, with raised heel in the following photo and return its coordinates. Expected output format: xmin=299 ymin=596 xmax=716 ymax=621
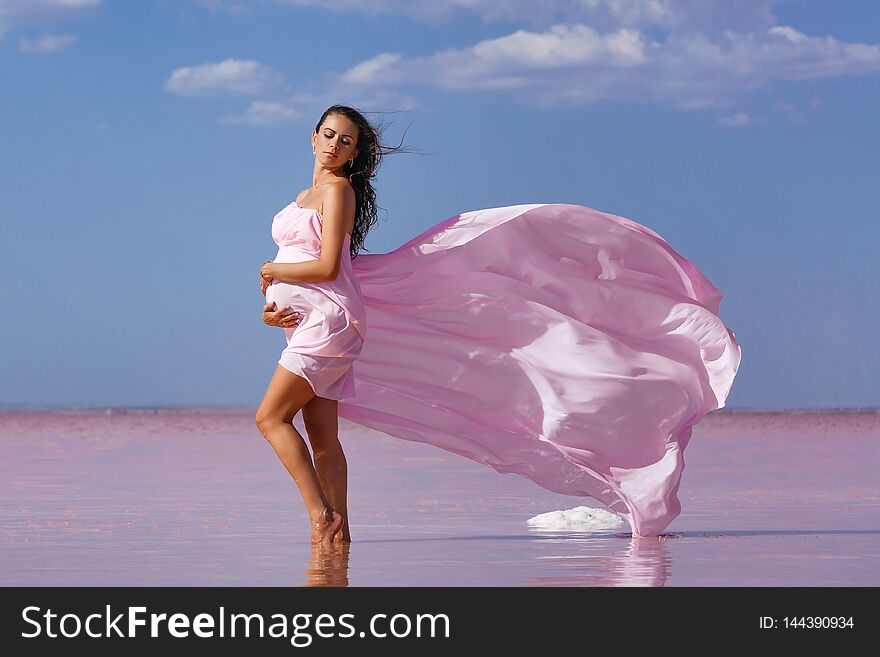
xmin=255 ymin=365 xmax=342 ymax=543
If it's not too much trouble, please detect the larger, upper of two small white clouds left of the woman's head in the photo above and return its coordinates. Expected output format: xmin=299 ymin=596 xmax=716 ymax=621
xmin=165 ymin=59 xmax=285 ymax=96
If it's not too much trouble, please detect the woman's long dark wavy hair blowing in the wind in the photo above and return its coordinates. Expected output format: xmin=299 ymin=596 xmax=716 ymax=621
xmin=315 ymin=105 xmax=422 ymax=258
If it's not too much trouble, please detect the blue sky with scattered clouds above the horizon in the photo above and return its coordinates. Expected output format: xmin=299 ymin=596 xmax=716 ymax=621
xmin=0 ymin=0 xmax=880 ymax=408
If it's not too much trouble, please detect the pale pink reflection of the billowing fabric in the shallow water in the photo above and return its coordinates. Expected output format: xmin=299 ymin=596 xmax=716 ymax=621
xmin=528 ymin=529 xmax=676 ymax=587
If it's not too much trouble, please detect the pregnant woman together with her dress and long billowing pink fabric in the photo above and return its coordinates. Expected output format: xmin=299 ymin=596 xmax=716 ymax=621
xmin=256 ymin=105 xmax=741 ymax=543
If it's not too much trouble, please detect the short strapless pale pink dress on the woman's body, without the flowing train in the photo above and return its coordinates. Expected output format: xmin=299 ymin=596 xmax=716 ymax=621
xmin=266 ymin=201 xmax=366 ymax=399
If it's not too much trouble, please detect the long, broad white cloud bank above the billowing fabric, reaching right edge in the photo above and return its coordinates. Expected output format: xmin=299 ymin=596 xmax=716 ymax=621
xmin=342 ymin=24 xmax=880 ymax=109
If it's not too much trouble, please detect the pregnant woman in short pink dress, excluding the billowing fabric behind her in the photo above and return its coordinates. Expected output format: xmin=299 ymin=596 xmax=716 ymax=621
xmin=256 ymin=106 xmax=380 ymax=543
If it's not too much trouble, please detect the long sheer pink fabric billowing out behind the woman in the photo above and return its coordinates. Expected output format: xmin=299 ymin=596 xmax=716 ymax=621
xmin=339 ymin=204 xmax=741 ymax=536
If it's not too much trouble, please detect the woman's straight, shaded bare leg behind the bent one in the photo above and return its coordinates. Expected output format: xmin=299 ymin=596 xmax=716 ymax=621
xmin=302 ymin=396 xmax=351 ymax=542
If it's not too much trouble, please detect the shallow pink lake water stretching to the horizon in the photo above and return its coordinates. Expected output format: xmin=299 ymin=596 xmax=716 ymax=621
xmin=0 ymin=409 xmax=880 ymax=586
